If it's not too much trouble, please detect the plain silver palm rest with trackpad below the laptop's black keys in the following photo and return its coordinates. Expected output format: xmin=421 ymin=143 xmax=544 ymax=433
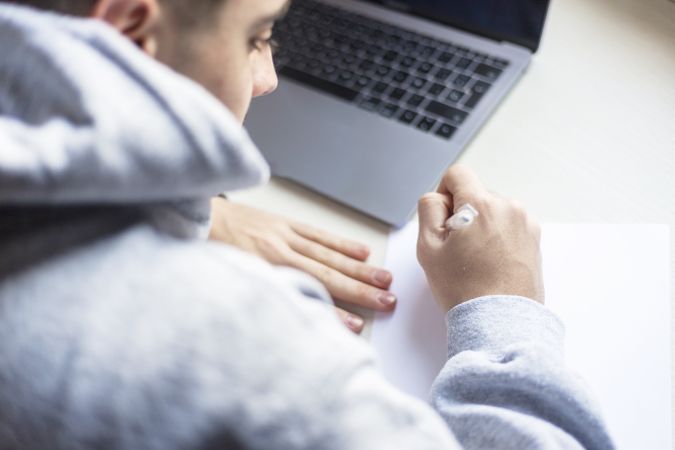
xmin=246 ymin=79 xmax=460 ymax=225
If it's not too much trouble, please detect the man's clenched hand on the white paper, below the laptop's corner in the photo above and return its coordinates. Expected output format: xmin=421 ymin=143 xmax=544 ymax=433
xmin=417 ymin=165 xmax=544 ymax=312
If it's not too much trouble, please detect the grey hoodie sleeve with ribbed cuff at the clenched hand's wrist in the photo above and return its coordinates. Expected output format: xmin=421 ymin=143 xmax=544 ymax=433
xmin=432 ymin=296 xmax=614 ymax=450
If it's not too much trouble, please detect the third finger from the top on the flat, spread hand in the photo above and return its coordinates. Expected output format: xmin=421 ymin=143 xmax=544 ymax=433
xmin=284 ymin=248 xmax=396 ymax=311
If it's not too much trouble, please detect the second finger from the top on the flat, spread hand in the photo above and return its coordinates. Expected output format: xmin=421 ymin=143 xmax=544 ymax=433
xmin=289 ymin=236 xmax=392 ymax=289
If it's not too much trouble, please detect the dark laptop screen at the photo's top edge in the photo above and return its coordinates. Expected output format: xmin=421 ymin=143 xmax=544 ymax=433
xmin=368 ymin=0 xmax=549 ymax=52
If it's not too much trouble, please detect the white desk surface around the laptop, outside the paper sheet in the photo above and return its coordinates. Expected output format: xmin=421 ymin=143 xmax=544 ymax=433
xmin=232 ymin=0 xmax=675 ymax=441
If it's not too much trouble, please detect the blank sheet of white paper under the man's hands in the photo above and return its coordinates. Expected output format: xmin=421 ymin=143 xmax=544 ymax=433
xmin=372 ymin=222 xmax=671 ymax=450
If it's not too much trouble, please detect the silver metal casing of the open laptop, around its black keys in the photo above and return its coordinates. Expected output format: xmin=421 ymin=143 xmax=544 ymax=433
xmin=246 ymin=0 xmax=552 ymax=226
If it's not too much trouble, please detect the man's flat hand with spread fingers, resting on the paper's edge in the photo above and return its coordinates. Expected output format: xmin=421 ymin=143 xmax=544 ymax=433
xmin=210 ymin=198 xmax=396 ymax=333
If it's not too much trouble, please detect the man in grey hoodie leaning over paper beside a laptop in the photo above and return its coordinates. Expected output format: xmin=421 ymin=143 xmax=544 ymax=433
xmin=0 ymin=0 xmax=612 ymax=449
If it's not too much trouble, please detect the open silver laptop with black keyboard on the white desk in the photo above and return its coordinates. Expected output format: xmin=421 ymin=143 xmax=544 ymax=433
xmin=246 ymin=0 xmax=549 ymax=226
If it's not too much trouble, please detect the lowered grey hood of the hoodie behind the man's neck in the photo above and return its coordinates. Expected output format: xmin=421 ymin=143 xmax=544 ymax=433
xmin=0 ymin=3 xmax=269 ymax=205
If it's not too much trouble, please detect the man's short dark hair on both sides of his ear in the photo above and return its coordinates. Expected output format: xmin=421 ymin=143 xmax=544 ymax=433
xmin=2 ymin=0 xmax=225 ymax=25
